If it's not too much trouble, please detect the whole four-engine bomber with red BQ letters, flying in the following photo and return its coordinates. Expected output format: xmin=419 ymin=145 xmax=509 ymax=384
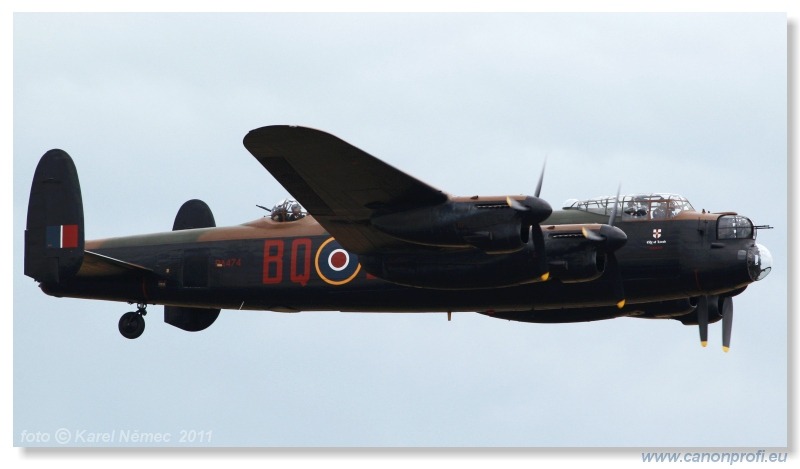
xmin=25 ymin=126 xmax=772 ymax=351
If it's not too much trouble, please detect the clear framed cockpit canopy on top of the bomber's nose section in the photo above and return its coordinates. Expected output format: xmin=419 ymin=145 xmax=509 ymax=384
xmin=564 ymin=194 xmax=694 ymax=220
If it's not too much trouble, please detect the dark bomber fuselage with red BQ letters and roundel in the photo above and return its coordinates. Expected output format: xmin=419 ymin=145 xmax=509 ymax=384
xmin=42 ymin=211 xmax=754 ymax=312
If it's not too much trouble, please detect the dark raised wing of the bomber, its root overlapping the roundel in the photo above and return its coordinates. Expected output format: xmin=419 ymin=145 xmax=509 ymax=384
xmin=244 ymin=125 xmax=448 ymax=253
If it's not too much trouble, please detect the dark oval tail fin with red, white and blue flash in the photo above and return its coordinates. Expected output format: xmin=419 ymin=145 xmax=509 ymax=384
xmin=25 ymin=149 xmax=84 ymax=283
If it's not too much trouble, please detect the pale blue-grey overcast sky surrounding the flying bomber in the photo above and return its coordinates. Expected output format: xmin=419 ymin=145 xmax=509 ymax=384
xmin=4 ymin=6 xmax=788 ymax=460
